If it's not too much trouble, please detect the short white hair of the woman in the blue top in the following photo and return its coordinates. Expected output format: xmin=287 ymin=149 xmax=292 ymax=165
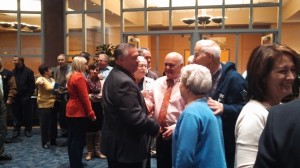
xmin=180 ymin=64 xmax=212 ymax=95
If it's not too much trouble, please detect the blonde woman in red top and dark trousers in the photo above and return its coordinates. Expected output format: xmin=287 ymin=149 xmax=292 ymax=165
xmin=66 ymin=56 xmax=96 ymax=168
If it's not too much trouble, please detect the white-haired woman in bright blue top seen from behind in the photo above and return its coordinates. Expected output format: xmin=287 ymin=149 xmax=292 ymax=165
xmin=172 ymin=64 xmax=226 ymax=168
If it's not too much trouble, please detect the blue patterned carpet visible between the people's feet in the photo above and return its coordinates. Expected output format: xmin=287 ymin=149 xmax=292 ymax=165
xmin=0 ymin=127 xmax=156 ymax=168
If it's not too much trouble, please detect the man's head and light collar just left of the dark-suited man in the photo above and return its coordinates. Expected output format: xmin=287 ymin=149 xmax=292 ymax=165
xmin=97 ymin=54 xmax=112 ymax=80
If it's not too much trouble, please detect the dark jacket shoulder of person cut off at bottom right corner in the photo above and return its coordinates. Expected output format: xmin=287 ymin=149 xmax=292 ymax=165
xmin=254 ymin=99 xmax=300 ymax=168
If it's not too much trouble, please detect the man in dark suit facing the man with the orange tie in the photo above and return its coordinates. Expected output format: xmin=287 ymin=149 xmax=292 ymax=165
xmin=101 ymin=43 xmax=159 ymax=168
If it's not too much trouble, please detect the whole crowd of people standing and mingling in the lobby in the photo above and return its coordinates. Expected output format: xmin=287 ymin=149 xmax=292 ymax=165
xmin=0 ymin=39 xmax=300 ymax=168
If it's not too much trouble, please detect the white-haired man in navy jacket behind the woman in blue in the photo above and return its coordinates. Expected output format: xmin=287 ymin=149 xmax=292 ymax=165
xmin=194 ymin=40 xmax=247 ymax=168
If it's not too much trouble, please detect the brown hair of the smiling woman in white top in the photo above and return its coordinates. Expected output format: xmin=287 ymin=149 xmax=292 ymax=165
xmin=247 ymin=44 xmax=300 ymax=101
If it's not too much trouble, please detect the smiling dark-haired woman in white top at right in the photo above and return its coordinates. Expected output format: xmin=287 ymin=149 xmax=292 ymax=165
xmin=235 ymin=44 xmax=299 ymax=167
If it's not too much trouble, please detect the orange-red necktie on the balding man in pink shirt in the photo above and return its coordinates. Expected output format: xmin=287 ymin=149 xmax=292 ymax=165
xmin=158 ymin=79 xmax=174 ymax=127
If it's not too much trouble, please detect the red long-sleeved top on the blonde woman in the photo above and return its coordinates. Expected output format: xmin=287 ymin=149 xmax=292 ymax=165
xmin=66 ymin=72 xmax=96 ymax=119
